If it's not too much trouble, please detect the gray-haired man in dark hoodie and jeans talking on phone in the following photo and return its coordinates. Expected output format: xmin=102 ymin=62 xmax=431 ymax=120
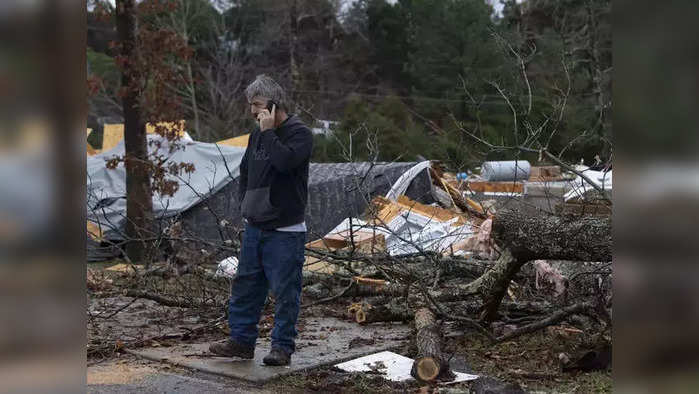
xmin=210 ymin=75 xmax=313 ymax=365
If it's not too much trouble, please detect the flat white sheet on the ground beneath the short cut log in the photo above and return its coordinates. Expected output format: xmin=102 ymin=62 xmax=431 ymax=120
xmin=335 ymin=351 xmax=478 ymax=384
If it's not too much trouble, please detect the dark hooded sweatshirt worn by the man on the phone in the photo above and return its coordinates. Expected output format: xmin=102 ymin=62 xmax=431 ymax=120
xmin=239 ymin=115 xmax=313 ymax=230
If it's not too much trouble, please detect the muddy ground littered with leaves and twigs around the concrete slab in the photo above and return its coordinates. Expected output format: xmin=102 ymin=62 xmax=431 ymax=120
xmin=87 ymin=261 xmax=612 ymax=393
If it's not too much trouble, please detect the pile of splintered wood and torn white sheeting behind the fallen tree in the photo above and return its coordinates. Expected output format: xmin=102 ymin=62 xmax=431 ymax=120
xmin=306 ymin=161 xmax=612 ymax=259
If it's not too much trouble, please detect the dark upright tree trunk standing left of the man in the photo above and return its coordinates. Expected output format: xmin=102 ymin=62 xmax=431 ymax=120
xmin=116 ymin=0 xmax=153 ymax=263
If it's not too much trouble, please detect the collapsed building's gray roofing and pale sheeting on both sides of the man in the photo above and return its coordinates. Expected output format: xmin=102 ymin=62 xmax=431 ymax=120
xmin=86 ymin=135 xmax=434 ymax=261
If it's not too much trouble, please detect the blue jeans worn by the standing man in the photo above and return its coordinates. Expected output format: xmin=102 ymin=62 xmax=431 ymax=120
xmin=228 ymin=224 xmax=306 ymax=354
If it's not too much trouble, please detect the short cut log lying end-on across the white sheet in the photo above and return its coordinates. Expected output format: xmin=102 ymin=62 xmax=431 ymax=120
xmin=410 ymin=308 xmax=454 ymax=382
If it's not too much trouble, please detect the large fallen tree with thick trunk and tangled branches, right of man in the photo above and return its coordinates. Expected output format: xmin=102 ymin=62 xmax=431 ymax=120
xmin=304 ymin=211 xmax=612 ymax=340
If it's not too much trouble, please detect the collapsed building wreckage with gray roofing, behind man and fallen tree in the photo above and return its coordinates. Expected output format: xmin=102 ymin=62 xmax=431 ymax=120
xmin=86 ymin=129 xmax=612 ymax=261
